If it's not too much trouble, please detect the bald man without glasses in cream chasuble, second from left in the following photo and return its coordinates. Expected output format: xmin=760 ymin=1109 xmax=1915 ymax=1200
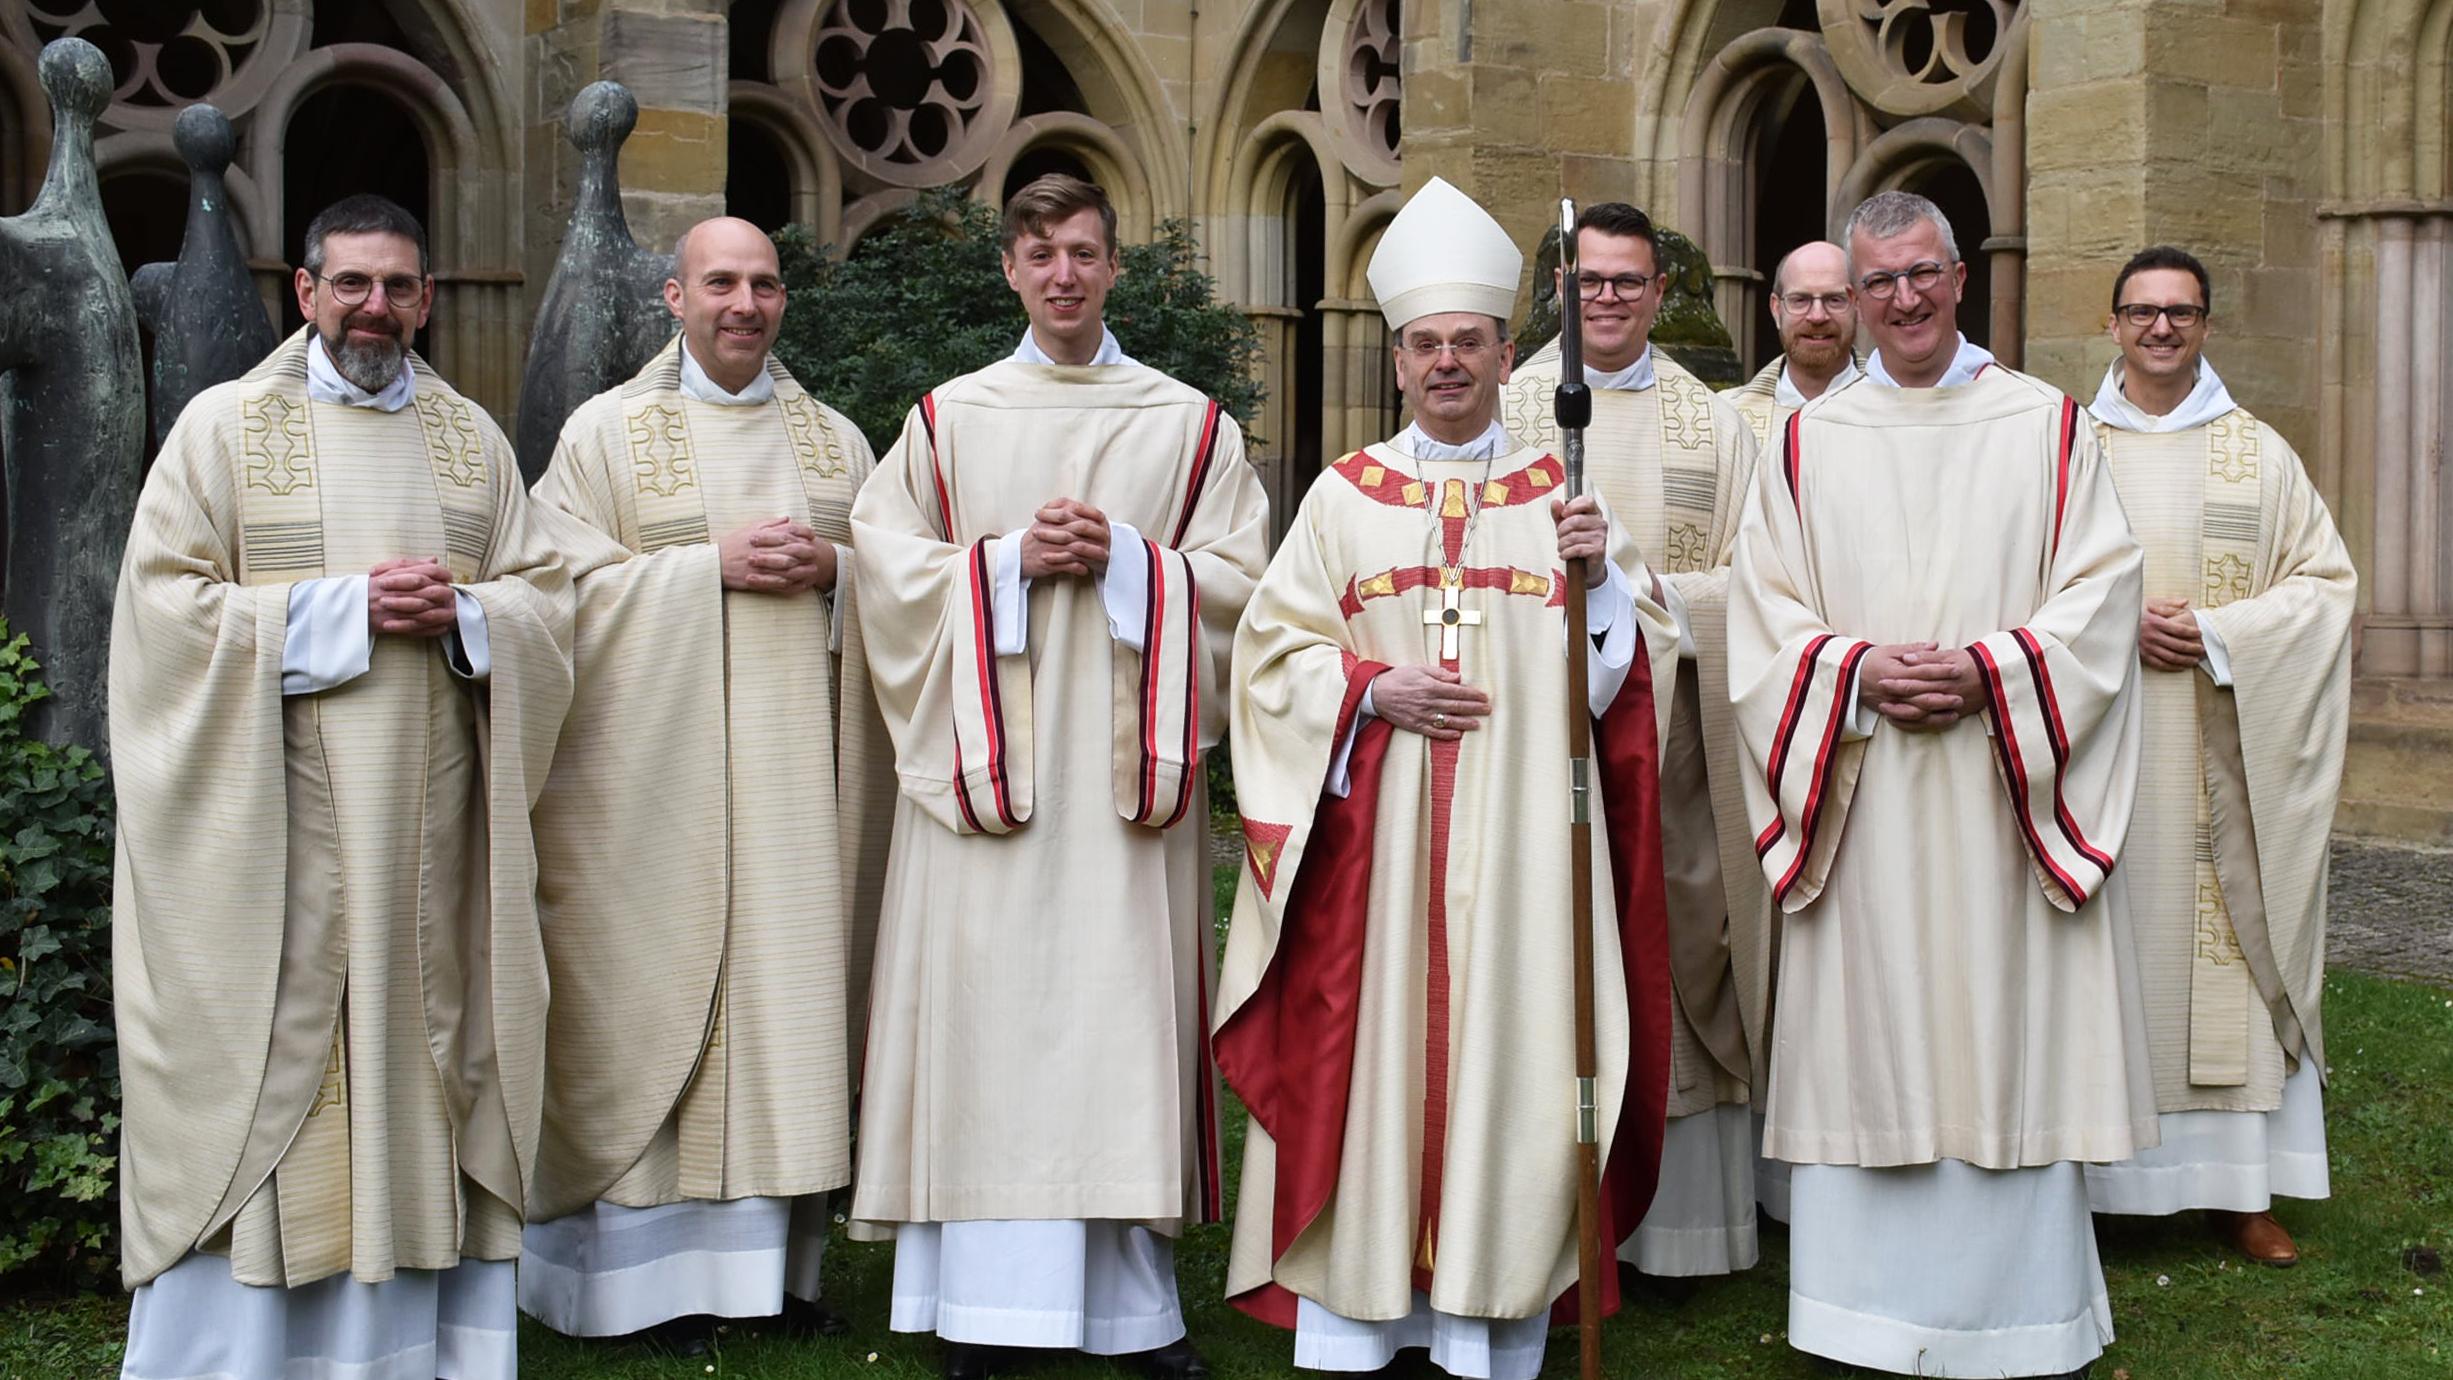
xmin=520 ymin=218 xmax=890 ymax=1351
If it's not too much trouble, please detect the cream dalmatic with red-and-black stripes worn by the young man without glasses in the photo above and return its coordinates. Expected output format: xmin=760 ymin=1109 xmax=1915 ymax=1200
xmin=851 ymin=360 xmax=1268 ymax=1238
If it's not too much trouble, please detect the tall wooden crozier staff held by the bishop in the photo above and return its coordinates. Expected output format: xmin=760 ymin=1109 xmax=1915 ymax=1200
xmin=1550 ymin=199 xmax=1602 ymax=1380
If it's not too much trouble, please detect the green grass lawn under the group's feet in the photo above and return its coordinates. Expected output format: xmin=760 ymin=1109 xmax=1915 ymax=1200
xmin=0 ymin=973 xmax=2453 ymax=1380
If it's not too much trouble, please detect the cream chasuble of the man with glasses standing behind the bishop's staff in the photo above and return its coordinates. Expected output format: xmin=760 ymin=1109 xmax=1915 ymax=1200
xmin=1504 ymin=341 xmax=1774 ymax=1118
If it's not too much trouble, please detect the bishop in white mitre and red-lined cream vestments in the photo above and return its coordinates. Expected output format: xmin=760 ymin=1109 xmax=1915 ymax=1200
xmin=1217 ymin=179 xmax=1678 ymax=1380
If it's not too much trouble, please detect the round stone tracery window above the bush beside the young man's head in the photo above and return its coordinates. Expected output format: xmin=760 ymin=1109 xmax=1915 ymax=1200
xmin=809 ymin=0 xmax=1016 ymax=186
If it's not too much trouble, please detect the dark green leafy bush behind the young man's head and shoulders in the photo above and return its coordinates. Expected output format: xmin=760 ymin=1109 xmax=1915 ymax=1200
xmin=775 ymin=186 xmax=1261 ymax=456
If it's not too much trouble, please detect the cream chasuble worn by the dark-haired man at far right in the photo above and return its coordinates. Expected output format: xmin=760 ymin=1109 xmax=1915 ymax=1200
xmin=2097 ymin=409 xmax=2357 ymax=1113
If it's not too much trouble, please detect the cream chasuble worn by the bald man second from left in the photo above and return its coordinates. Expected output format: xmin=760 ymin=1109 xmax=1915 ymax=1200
xmin=535 ymin=346 xmax=886 ymax=1218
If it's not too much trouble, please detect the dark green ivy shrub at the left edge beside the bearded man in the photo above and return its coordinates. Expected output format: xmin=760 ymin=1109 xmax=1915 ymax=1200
xmin=0 ymin=623 xmax=120 ymax=1284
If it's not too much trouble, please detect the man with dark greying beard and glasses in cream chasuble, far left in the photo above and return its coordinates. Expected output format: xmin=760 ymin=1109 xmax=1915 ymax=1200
xmin=110 ymin=196 xmax=608 ymax=1380
